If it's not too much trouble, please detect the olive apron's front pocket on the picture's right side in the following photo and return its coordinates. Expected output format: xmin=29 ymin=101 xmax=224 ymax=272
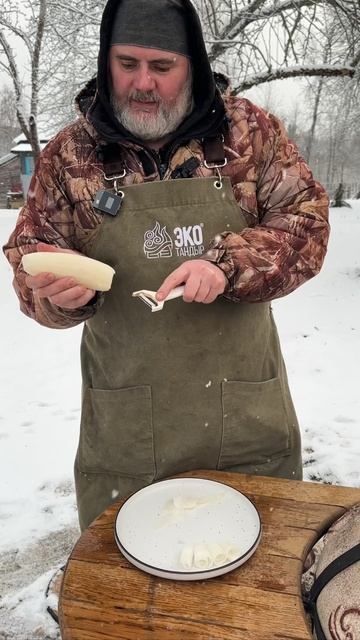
xmin=218 ymin=378 xmax=291 ymax=469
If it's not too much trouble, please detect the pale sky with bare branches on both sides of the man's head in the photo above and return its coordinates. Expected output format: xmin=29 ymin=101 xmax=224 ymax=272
xmin=0 ymin=0 xmax=360 ymax=155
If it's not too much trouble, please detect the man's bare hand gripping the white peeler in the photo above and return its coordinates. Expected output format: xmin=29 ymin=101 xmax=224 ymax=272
xmin=156 ymin=260 xmax=227 ymax=304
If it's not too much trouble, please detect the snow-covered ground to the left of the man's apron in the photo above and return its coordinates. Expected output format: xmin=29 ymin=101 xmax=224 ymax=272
xmin=0 ymin=211 xmax=81 ymax=640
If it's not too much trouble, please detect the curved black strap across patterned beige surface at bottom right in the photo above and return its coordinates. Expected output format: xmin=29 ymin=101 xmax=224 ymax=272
xmin=304 ymin=544 xmax=360 ymax=640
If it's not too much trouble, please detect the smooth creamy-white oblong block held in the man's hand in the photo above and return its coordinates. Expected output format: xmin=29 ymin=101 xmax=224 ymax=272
xmin=22 ymin=251 xmax=115 ymax=291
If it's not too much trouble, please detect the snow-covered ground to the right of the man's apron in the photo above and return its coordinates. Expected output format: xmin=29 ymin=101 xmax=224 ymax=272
xmin=274 ymin=200 xmax=360 ymax=488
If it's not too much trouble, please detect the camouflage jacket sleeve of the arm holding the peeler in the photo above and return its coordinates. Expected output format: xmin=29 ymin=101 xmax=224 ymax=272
xmin=207 ymin=109 xmax=329 ymax=302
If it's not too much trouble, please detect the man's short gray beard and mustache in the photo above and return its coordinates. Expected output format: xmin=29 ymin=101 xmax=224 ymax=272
xmin=111 ymin=73 xmax=193 ymax=140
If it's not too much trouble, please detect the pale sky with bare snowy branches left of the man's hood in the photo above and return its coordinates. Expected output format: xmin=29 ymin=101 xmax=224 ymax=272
xmin=0 ymin=0 xmax=104 ymax=158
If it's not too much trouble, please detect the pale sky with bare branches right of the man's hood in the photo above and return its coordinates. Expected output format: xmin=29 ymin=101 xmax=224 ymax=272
xmin=197 ymin=0 xmax=360 ymax=93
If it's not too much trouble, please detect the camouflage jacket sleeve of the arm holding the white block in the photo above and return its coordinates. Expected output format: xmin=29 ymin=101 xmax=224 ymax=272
xmin=3 ymin=144 xmax=102 ymax=329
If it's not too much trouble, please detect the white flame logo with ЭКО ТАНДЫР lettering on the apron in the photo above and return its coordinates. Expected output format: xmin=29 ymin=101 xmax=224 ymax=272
xmin=144 ymin=222 xmax=204 ymax=258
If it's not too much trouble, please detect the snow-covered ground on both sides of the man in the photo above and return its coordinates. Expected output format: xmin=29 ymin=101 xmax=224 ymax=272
xmin=0 ymin=201 xmax=360 ymax=640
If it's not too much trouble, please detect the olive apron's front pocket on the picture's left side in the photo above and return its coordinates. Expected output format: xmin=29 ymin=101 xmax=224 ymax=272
xmin=78 ymin=385 xmax=155 ymax=479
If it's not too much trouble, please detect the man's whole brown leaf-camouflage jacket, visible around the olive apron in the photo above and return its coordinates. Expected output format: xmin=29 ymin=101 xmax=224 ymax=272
xmin=4 ymin=96 xmax=329 ymax=328
